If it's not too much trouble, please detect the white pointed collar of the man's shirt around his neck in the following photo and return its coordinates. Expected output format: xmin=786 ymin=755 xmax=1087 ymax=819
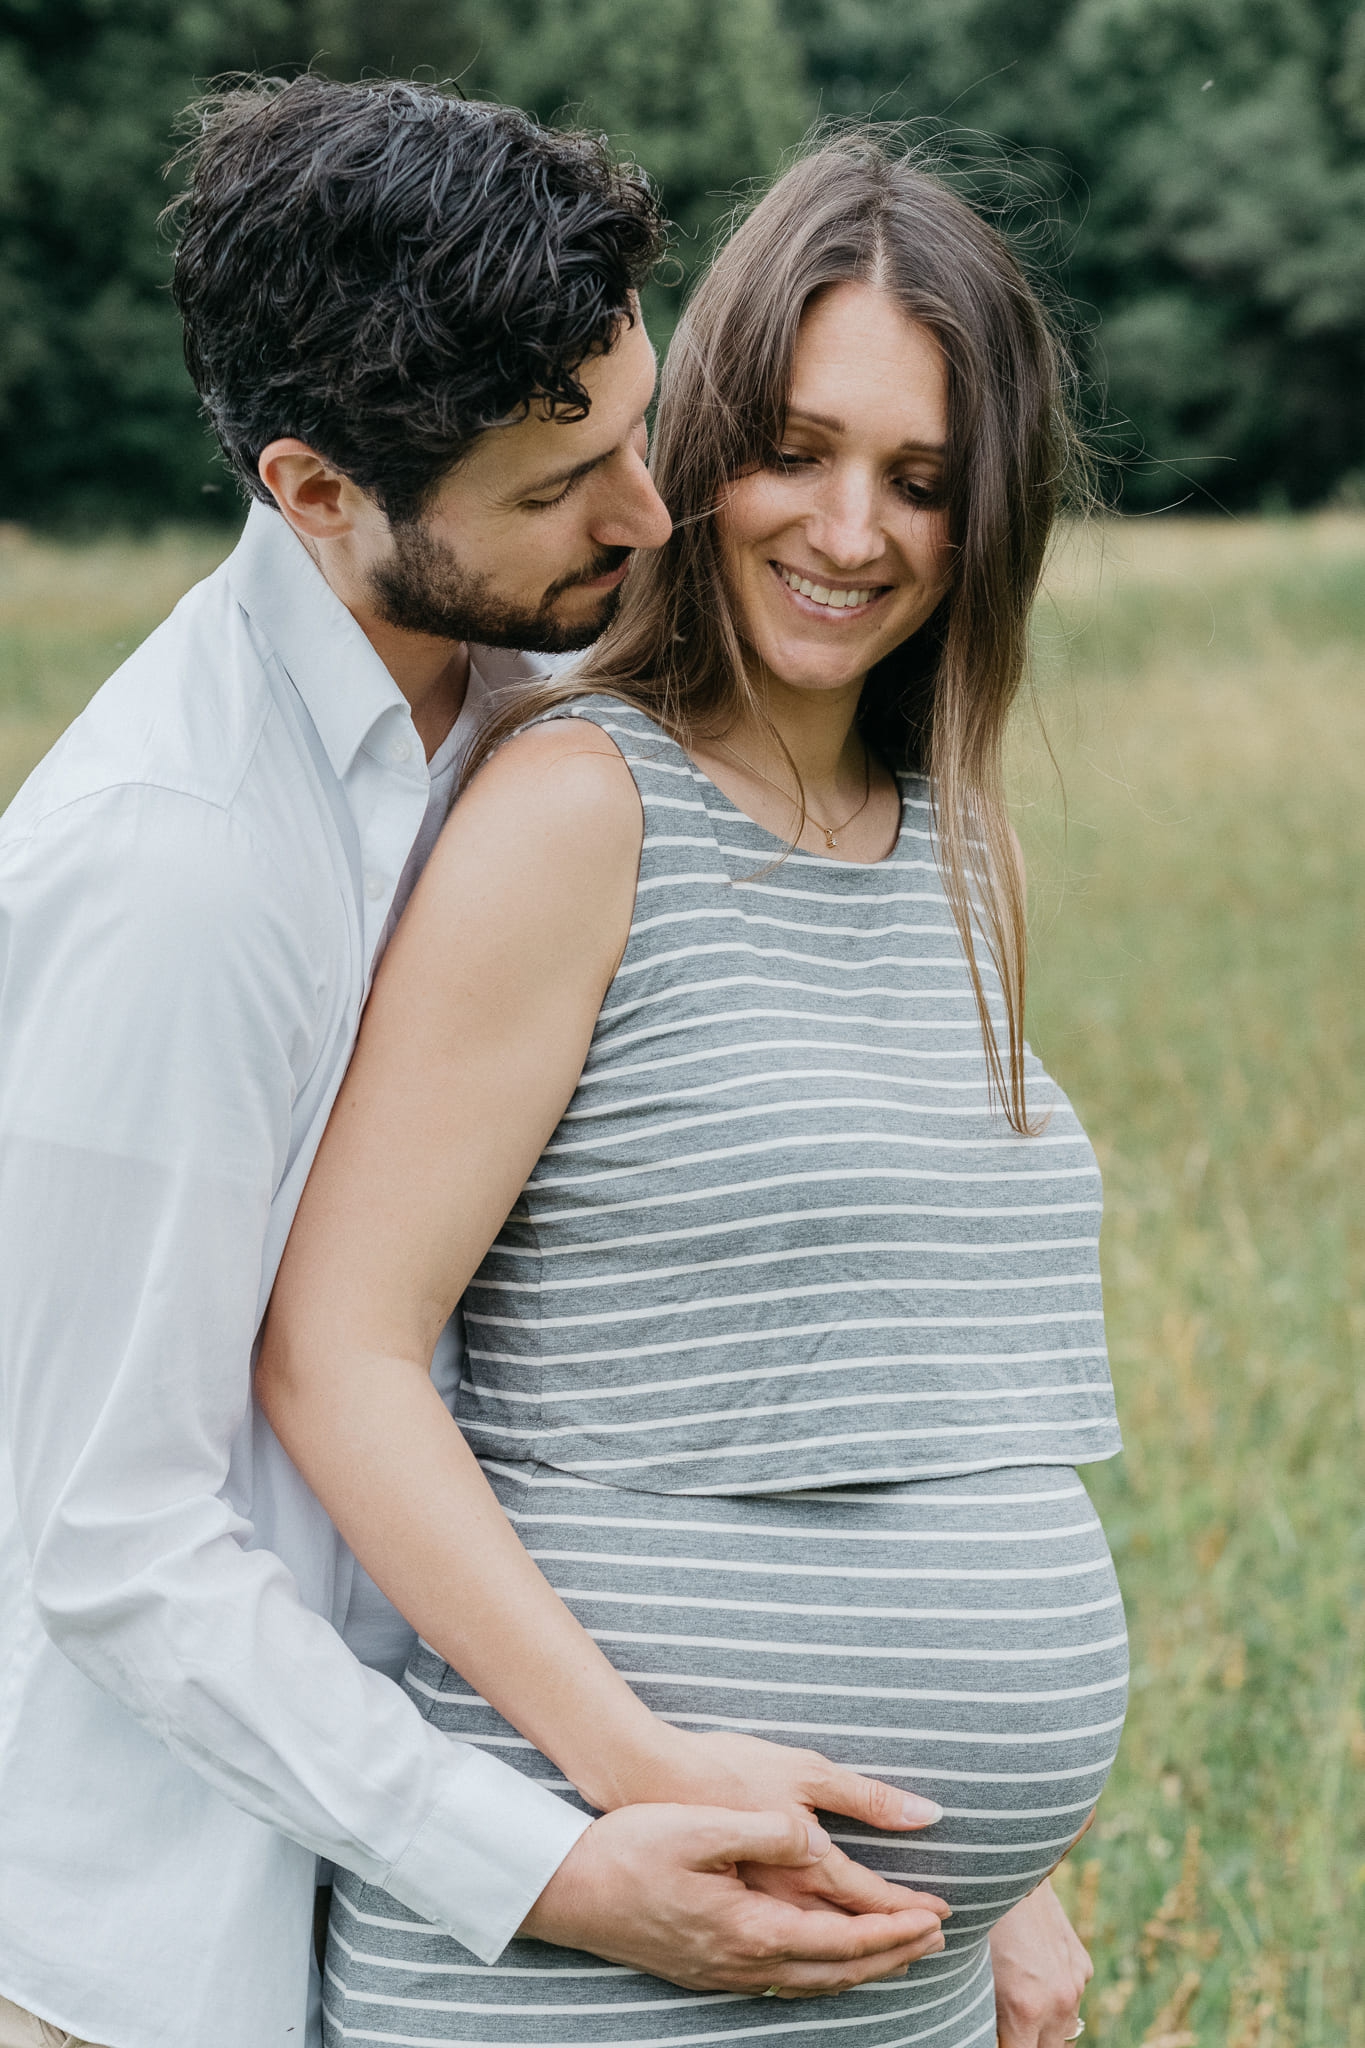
xmin=227 ymin=500 xmax=557 ymax=778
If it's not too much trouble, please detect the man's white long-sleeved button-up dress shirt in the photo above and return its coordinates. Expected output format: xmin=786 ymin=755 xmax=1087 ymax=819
xmin=0 ymin=506 xmax=585 ymax=2048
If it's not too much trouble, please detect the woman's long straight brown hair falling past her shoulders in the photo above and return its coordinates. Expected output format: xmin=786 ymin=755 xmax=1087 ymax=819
xmin=469 ymin=135 xmax=1078 ymax=1133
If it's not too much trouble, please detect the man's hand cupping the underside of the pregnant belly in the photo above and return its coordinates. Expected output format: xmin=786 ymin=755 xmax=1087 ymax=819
xmin=522 ymin=1806 xmax=943 ymax=1999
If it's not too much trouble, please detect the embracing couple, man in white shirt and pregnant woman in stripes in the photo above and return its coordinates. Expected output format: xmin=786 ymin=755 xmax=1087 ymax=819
xmin=0 ymin=78 xmax=1126 ymax=2048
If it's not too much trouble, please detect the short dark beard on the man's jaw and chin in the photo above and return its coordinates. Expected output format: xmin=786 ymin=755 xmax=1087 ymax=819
xmin=370 ymin=520 xmax=630 ymax=653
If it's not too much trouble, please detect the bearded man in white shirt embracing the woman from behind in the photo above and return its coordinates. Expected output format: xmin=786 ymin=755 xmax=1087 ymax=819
xmin=0 ymin=78 xmax=1096 ymax=2048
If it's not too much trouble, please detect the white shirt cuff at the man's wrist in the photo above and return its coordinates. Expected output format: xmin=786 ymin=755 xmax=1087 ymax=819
xmin=383 ymin=1749 xmax=593 ymax=1962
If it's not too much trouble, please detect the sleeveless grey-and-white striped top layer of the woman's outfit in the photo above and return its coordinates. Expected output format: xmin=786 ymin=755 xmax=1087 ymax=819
xmin=458 ymin=696 xmax=1119 ymax=1493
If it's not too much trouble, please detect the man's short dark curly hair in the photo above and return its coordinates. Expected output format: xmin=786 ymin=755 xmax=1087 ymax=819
xmin=170 ymin=74 xmax=663 ymax=522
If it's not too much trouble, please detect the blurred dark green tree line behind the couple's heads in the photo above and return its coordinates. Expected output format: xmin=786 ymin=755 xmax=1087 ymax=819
xmin=0 ymin=0 xmax=1365 ymax=524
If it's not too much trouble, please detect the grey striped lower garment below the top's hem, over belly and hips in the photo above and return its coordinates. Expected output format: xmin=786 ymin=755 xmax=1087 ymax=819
xmin=323 ymin=1464 xmax=1128 ymax=2048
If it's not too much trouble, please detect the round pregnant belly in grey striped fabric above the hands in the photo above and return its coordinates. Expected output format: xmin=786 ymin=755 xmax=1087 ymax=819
xmin=407 ymin=1466 xmax=1128 ymax=1952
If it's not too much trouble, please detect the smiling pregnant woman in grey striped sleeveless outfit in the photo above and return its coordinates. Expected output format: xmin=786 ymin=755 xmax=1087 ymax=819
xmin=260 ymin=141 xmax=1126 ymax=2048
